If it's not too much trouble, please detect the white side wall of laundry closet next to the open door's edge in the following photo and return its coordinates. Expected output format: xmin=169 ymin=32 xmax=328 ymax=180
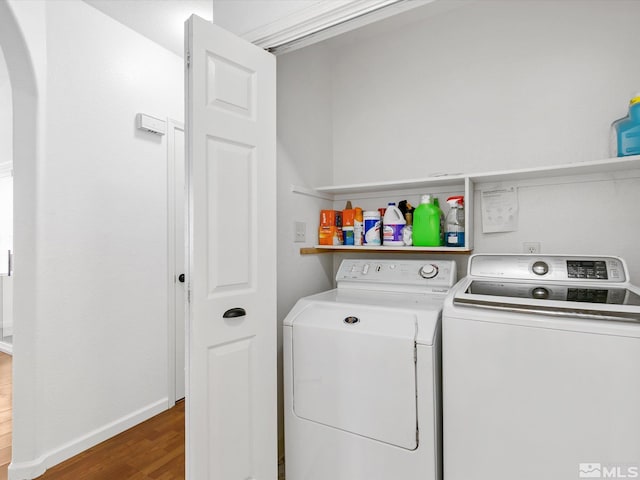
xmin=276 ymin=42 xmax=333 ymax=452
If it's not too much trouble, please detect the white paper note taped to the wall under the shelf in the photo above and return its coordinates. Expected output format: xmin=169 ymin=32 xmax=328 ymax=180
xmin=481 ymin=187 xmax=518 ymax=233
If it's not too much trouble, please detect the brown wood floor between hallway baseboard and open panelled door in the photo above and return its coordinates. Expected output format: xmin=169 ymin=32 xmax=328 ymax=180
xmin=38 ymin=401 xmax=185 ymax=480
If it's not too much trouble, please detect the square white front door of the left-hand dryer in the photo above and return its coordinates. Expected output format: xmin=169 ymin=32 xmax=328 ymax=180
xmin=293 ymin=304 xmax=418 ymax=450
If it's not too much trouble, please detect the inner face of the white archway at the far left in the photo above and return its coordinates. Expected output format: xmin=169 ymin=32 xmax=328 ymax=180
xmin=0 ymin=0 xmax=42 ymax=478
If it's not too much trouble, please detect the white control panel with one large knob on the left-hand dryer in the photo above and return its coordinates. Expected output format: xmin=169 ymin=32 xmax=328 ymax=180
xmin=336 ymin=259 xmax=457 ymax=293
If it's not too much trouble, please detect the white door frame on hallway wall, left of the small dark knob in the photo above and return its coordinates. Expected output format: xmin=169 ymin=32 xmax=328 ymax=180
xmin=167 ymin=118 xmax=186 ymax=408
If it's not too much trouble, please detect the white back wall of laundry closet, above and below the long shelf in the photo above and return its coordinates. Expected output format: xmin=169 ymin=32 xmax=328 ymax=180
xmin=283 ymin=0 xmax=640 ymax=284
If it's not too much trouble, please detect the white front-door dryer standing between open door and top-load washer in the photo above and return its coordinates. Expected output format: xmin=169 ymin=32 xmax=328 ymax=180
xmin=283 ymin=260 xmax=456 ymax=480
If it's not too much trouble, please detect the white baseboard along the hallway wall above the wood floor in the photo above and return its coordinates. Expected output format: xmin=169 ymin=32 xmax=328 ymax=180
xmin=9 ymin=398 xmax=168 ymax=480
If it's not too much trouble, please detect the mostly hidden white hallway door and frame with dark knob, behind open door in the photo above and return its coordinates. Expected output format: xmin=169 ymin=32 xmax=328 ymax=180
xmin=167 ymin=119 xmax=187 ymax=406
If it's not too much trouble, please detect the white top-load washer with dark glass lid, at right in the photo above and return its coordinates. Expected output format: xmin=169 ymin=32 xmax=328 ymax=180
xmin=442 ymin=255 xmax=640 ymax=480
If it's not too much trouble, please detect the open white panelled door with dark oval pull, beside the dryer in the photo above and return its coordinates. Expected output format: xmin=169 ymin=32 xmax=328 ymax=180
xmin=185 ymin=16 xmax=277 ymax=480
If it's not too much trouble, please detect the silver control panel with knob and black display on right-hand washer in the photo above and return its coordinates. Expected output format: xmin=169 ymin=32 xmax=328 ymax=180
xmin=469 ymin=254 xmax=629 ymax=283
